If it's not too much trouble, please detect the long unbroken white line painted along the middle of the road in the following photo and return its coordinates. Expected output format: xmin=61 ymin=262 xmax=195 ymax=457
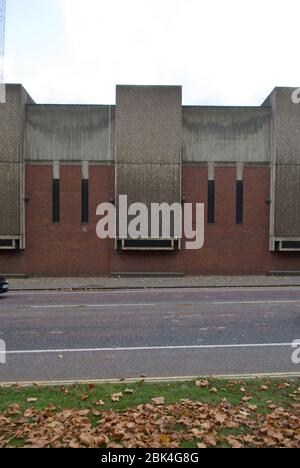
xmin=6 ymin=343 xmax=293 ymax=355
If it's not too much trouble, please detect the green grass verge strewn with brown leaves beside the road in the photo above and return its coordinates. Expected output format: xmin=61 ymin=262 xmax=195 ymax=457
xmin=0 ymin=379 xmax=300 ymax=448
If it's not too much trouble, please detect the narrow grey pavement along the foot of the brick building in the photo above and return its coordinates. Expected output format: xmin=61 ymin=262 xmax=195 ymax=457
xmin=5 ymin=274 xmax=300 ymax=291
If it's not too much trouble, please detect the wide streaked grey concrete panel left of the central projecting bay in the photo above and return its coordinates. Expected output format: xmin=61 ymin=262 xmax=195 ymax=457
xmin=26 ymin=105 xmax=115 ymax=163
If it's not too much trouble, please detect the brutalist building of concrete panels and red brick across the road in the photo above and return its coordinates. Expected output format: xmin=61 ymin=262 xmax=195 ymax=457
xmin=0 ymin=85 xmax=300 ymax=275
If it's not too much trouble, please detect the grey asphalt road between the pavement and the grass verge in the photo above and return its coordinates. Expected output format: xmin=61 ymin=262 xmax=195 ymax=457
xmin=0 ymin=287 xmax=300 ymax=382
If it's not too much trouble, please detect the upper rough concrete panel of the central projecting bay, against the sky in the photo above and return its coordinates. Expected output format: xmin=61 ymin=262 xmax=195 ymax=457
xmin=116 ymin=86 xmax=182 ymax=164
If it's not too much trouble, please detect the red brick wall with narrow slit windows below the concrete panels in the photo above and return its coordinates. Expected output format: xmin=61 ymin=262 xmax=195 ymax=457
xmin=0 ymin=165 xmax=300 ymax=276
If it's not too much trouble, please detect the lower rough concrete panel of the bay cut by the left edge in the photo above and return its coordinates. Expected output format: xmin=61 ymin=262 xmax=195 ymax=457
xmin=0 ymin=163 xmax=21 ymax=238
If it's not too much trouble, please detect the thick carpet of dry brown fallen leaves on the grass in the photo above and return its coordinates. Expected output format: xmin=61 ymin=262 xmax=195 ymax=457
xmin=0 ymin=383 xmax=300 ymax=449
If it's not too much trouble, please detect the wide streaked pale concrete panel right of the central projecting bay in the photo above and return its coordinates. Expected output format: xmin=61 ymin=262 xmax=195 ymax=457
xmin=183 ymin=107 xmax=271 ymax=163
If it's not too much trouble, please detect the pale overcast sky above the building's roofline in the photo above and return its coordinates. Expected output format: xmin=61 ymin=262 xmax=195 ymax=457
xmin=4 ymin=0 xmax=300 ymax=105
